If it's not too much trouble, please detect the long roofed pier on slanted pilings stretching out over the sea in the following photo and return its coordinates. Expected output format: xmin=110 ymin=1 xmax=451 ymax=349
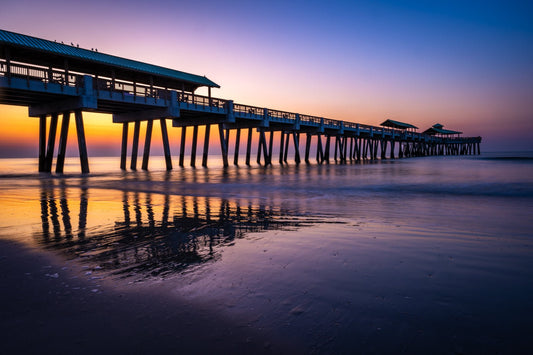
xmin=0 ymin=30 xmax=481 ymax=173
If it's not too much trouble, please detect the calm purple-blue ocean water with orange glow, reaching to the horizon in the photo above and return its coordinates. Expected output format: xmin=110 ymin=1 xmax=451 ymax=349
xmin=0 ymin=152 xmax=533 ymax=354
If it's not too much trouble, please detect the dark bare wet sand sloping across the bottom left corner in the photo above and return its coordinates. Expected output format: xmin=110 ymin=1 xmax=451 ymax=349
xmin=0 ymin=240 xmax=301 ymax=354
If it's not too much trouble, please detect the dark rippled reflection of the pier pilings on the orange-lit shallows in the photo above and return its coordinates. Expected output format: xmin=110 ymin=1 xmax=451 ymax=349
xmin=35 ymin=179 xmax=319 ymax=278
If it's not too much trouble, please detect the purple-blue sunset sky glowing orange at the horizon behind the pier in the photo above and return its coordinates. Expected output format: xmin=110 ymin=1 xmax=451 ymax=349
xmin=0 ymin=0 xmax=533 ymax=157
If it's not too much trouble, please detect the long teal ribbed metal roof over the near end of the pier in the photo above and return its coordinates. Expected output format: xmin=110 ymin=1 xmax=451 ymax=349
xmin=0 ymin=29 xmax=220 ymax=88
